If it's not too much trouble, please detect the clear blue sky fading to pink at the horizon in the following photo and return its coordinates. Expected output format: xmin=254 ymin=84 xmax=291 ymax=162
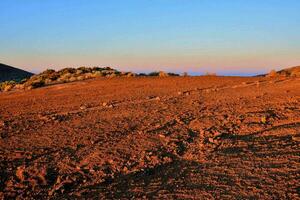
xmin=0 ymin=0 xmax=300 ymax=75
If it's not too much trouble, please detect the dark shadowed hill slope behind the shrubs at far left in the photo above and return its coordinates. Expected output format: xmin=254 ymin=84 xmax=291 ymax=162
xmin=0 ymin=63 xmax=33 ymax=82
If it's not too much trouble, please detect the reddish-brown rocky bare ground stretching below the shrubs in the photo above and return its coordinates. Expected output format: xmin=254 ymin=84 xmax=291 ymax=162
xmin=0 ymin=77 xmax=300 ymax=199
